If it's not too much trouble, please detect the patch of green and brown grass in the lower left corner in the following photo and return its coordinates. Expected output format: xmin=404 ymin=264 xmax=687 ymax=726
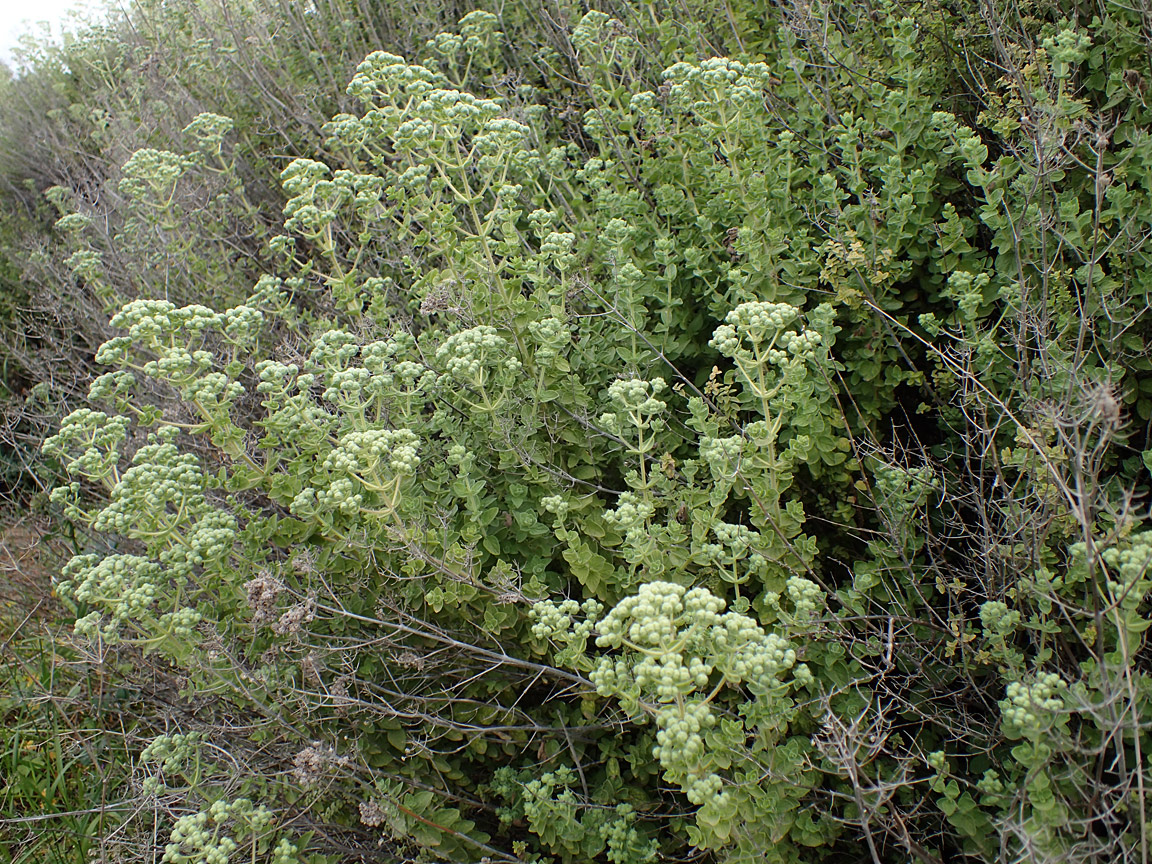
xmin=0 ymin=518 xmax=131 ymax=864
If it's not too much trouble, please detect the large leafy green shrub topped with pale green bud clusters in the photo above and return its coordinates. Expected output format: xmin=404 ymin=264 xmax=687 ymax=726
xmin=46 ymin=7 xmax=1152 ymax=863
